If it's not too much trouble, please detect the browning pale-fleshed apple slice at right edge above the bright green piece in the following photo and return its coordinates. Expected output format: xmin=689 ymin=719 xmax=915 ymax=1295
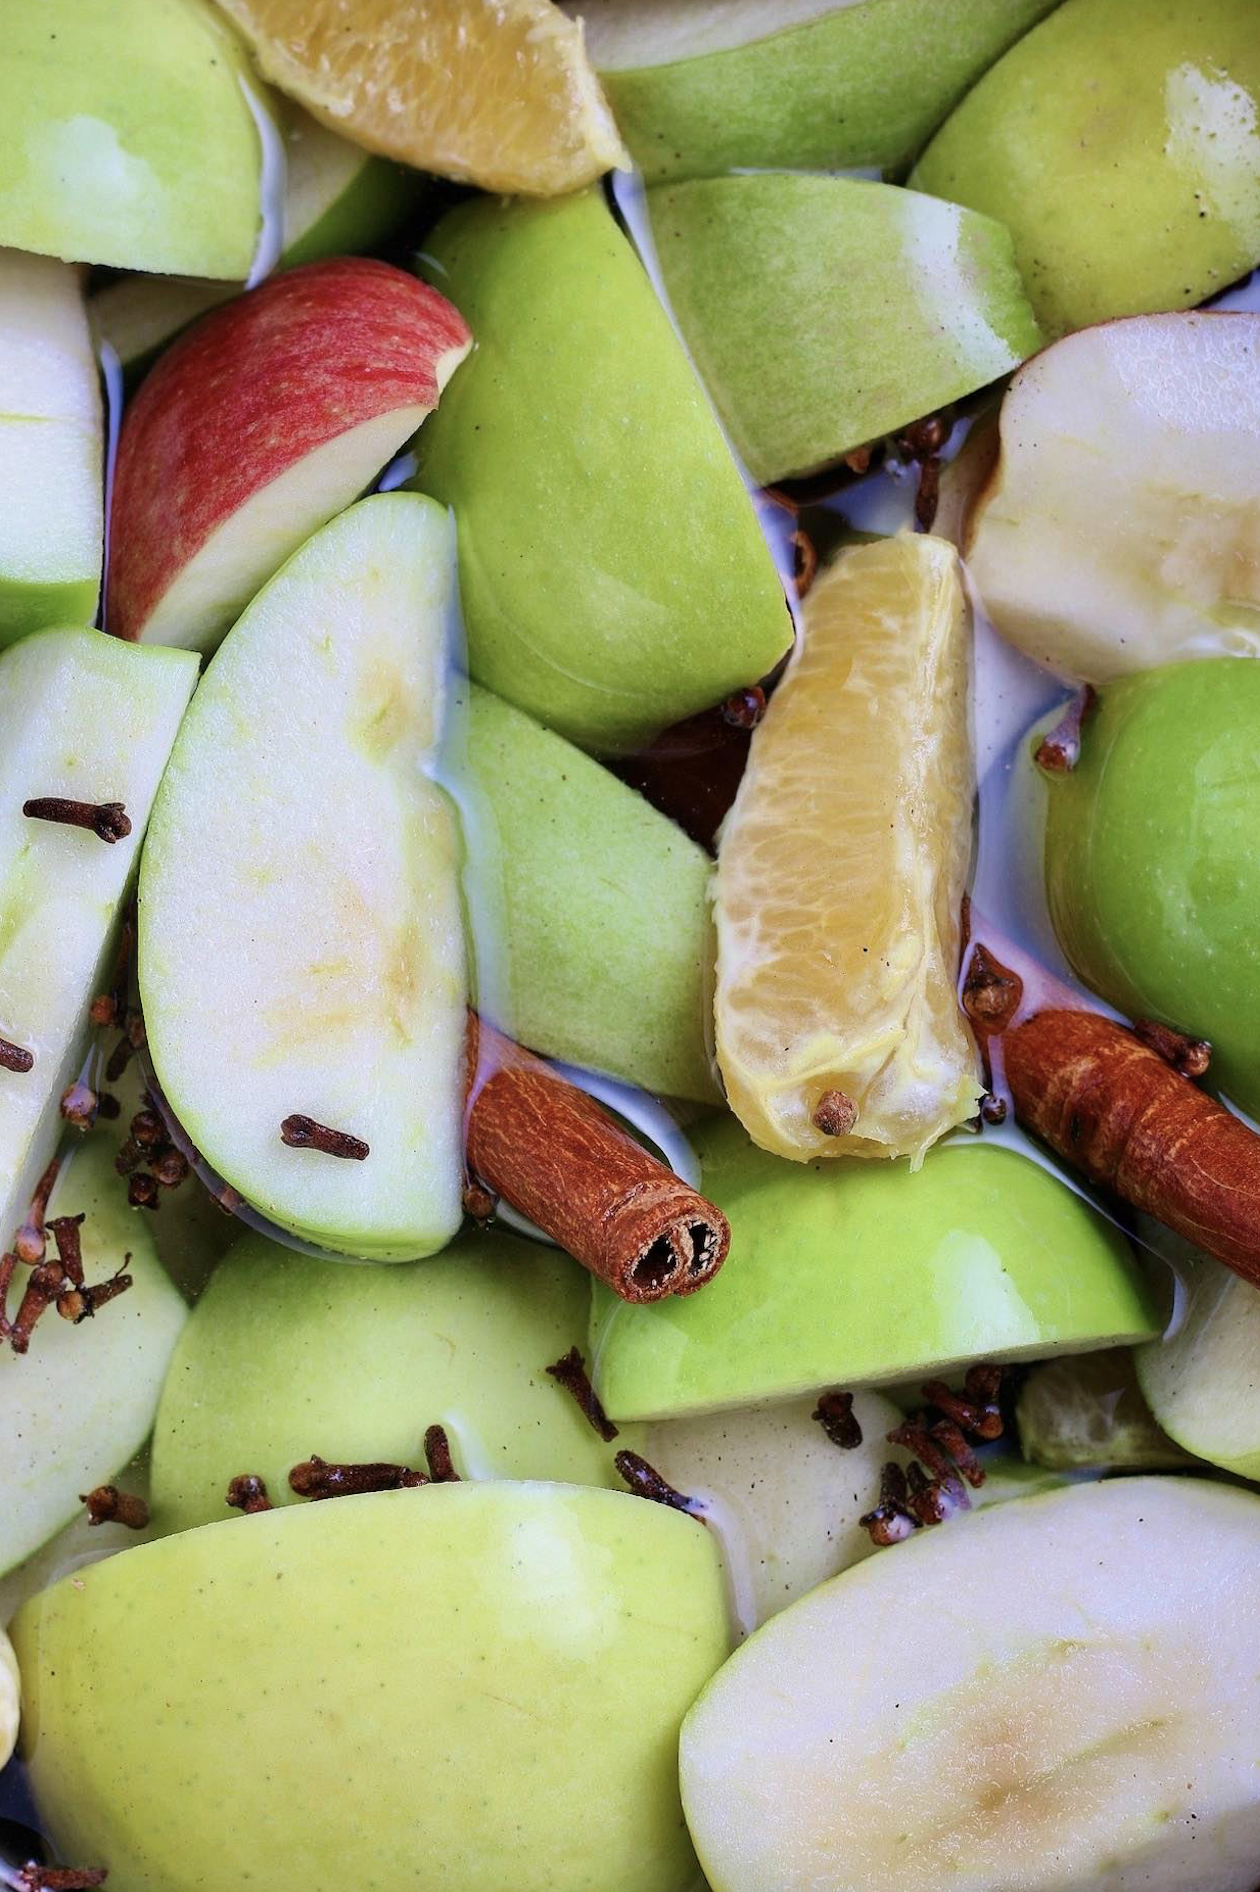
xmin=967 ymin=314 xmax=1260 ymax=683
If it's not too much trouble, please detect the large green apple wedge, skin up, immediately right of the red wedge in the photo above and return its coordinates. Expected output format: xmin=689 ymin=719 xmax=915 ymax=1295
xmin=416 ymin=191 xmax=791 ymax=751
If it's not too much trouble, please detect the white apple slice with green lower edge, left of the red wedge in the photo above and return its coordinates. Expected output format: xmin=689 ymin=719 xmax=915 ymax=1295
xmin=0 ymin=250 xmax=104 ymax=643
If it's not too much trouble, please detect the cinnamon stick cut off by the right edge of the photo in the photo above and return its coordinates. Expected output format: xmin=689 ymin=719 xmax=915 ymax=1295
xmin=1001 ymin=1008 xmax=1260 ymax=1287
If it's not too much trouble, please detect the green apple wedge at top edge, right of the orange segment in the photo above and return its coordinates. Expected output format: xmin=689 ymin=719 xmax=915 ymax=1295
xmin=566 ymin=0 xmax=1054 ymax=184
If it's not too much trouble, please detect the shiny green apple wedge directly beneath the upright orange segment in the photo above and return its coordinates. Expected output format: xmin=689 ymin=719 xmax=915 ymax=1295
xmin=590 ymin=1118 xmax=1162 ymax=1421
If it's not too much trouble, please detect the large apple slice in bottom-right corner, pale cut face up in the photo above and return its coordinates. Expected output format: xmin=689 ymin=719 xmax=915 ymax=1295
xmin=681 ymin=1478 xmax=1260 ymax=1892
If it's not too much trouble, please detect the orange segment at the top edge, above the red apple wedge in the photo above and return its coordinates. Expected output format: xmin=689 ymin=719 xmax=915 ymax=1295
xmin=219 ymin=0 xmax=630 ymax=197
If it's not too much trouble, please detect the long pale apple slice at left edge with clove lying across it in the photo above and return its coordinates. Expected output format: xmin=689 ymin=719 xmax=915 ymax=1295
xmin=0 ymin=630 xmax=197 ymax=1245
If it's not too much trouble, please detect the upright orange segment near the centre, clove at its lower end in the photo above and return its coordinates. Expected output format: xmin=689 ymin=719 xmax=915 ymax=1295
xmin=717 ymin=535 xmax=982 ymax=1164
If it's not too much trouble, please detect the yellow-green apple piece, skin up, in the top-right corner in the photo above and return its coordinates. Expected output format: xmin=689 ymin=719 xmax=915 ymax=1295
xmin=910 ymin=0 xmax=1260 ymax=335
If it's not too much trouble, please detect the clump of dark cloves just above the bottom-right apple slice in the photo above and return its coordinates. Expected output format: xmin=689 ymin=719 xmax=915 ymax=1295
xmin=861 ymin=1366 xmax=1003 ymax=1544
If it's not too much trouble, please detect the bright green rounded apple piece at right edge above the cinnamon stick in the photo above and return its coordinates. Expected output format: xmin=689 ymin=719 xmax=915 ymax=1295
xmin=1046 ymin=657 xmax=1260 ymax=1114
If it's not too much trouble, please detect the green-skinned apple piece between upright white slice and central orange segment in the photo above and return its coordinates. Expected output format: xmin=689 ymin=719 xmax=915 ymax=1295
xmin=445 ymin=685 xmax=715 ymax=1101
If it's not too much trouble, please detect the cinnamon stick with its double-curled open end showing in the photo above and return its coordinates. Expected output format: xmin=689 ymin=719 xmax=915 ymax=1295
xmin=465 ymin=1014 xmax=730 ymax=1302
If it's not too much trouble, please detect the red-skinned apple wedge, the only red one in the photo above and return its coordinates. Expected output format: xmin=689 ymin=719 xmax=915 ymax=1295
xmin=106 ymin=257 xmax=471 ymax=651
